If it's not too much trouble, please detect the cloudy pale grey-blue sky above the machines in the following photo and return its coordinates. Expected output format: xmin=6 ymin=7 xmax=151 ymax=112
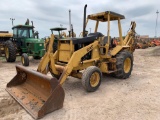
xmin=0 ymin=0 xmax=160 ymax=38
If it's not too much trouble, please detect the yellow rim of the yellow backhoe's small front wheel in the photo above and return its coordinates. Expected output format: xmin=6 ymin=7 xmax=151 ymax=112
xmin=90 ymin=72 xmax=100 ymax=87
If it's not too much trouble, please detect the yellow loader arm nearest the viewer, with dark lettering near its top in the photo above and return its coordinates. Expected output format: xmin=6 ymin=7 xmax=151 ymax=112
xmin=59 ymin=41 xmax=99 ymax=85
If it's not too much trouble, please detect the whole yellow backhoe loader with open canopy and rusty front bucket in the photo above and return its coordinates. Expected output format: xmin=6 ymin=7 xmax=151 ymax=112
xmin=6 ymin=5 xmax=136 ymax=119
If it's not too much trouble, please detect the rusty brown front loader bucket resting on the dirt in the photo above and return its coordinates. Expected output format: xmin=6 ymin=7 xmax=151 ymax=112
xmin=6 ymin=65 xmax=65 ymax=119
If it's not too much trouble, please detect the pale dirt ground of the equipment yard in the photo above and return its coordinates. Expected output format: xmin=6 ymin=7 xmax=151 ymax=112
xmin=0 ymin=47 xmax=160 ymax=120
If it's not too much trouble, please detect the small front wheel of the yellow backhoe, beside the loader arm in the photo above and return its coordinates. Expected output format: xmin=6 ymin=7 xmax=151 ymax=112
xmin=82 ymin=66 xmax=102 ymax=92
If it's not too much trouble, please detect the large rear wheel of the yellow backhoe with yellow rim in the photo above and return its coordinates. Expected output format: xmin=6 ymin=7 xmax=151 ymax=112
xmin=114 ymin=51 xmax=133 ymax=79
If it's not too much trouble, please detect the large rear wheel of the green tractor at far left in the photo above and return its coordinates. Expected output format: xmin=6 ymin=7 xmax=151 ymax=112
xmin=4 ymin=40 xmax=16 ymax=62
